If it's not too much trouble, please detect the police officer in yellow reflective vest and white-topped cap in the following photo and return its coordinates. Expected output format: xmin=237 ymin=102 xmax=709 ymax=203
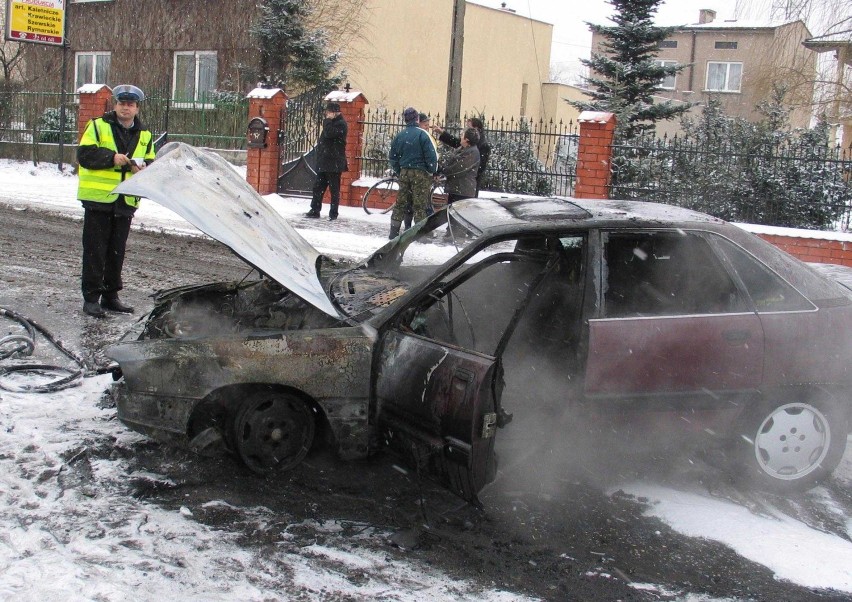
xmin=77 ymin=85 xmax=154 ymax=318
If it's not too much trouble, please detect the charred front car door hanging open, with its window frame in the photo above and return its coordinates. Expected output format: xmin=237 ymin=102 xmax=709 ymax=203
xmin=375 ymin=232 xmax=558 ymax=501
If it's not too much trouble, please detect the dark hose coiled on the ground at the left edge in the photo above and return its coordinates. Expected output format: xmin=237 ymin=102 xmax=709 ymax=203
xmin=0 ymin=307 xmax=106 ymax=393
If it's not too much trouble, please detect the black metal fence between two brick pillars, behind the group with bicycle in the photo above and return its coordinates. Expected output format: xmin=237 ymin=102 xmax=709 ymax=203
xmin=360 ymin=109 xmax=579 ymax=195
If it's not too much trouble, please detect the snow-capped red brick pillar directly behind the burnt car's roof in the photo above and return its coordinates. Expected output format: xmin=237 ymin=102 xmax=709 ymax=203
xmin=574 ymin=111 xmax=615 ymax=199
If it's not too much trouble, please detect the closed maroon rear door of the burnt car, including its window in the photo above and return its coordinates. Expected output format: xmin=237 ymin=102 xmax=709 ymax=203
xmin=585 ymin=230 xmax=764 ymax=401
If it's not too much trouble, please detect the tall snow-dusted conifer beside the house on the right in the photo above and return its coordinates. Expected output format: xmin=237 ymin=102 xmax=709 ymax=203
xmin=569 ymin=0 xmax=689 ymax=139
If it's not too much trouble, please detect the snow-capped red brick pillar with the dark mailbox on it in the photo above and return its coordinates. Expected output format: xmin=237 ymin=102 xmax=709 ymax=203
xmin=246 ymin=88 xmax=287 ymax=194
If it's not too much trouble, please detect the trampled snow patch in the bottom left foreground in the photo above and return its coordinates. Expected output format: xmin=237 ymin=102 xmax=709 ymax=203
xmin=0 ymin=376 xmax=524 ymax=602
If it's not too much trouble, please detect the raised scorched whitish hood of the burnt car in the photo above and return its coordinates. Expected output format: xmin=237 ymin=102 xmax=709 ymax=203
xmin=115 ymin=142 xmax=340 ymax=318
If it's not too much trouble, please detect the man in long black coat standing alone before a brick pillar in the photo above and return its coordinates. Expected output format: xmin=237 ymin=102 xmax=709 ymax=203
xmin=305 ymin=102 xmax=349 ymax=221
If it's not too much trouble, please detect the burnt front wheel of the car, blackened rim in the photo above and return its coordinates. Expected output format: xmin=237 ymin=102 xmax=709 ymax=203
xmin=234 ymin=391 xmax=315 ymax=474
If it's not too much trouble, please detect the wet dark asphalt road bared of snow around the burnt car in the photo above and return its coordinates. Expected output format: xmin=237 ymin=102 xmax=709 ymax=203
xmin=0 ymin=201 xmax=852 ymax=602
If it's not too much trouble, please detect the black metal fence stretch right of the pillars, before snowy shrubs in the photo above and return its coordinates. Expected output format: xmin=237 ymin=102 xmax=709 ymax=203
xmin=609 ymin=136 xmax=852 ymax=231
